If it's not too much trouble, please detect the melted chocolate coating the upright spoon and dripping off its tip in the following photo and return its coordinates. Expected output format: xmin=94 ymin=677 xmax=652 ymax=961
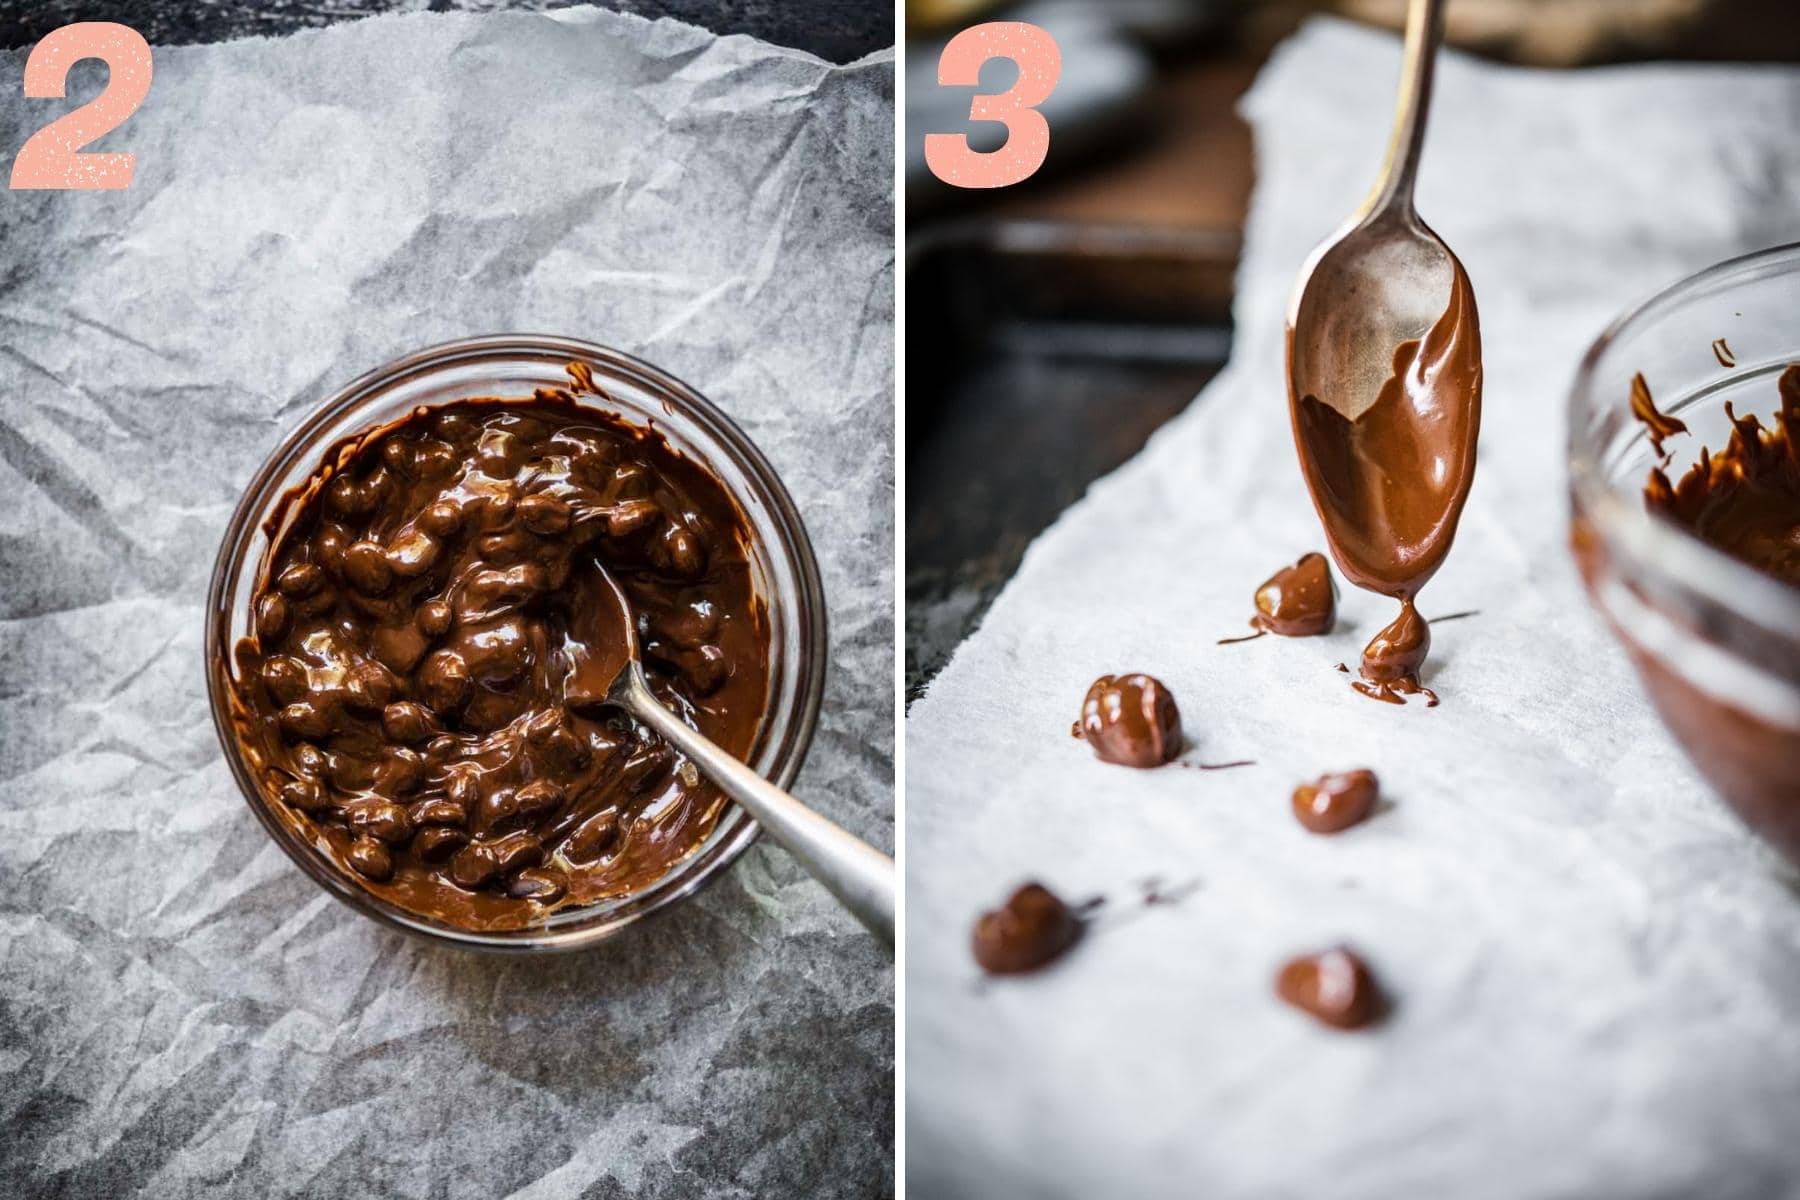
xmin=1287 ymin=255 xmax=1481 ymax=702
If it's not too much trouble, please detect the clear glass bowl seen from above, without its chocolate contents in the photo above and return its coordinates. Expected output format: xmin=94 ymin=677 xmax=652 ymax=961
xmin=205 ymin=335 xmax=826 ymax=950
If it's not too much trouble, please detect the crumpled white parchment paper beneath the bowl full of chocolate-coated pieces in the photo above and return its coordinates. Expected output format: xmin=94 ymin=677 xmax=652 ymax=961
xmin=0 ymin=9 xmax=893 ymax=1200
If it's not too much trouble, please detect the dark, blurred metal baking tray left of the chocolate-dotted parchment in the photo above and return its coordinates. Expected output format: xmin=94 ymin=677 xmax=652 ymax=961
xmin=905 ymin=221 xmax=1238 ymax=703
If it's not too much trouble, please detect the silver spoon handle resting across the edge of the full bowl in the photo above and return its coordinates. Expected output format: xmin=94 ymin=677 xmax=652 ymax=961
xmin=614 ymin=667 xmax=895 ymax=950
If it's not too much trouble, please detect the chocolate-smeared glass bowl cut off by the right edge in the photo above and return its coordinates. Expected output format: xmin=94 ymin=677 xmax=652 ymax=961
xmin=1568 ymin=245 xmax=1800 ymax=865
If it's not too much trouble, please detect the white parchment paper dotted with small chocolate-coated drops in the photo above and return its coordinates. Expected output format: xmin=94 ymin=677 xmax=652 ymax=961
xmin=905 ymin=23 xmax=1800 ymax=1198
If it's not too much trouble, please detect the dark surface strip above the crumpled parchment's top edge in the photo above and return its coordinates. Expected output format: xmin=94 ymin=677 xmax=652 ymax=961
xmin=0 ymin=0 xmax=895 ymax=63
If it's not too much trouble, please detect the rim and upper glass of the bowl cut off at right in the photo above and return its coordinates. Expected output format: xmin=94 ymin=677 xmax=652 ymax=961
xmin=1566 ymin=241 xmax=1800 ymax=630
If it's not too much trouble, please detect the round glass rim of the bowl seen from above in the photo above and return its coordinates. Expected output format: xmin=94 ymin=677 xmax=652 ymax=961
xmin=202 ymin=333 xmax=830 ymax=954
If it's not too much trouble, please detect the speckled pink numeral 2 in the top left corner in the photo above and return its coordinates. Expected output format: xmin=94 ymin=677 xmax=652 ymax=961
xmin=13 ymin=22 xmax=151 ymax=191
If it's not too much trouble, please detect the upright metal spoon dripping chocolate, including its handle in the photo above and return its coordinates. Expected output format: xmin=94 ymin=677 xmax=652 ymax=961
xmin=1287 ymin=0 xmax=1481 ymax=618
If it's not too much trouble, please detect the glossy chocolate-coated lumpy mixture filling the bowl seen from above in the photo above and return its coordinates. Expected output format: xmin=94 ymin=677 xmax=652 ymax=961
xmin=234 ymin=370 xmax=769 ymax=930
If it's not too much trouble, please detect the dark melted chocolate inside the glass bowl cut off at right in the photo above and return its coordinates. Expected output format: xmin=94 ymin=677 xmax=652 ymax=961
xmin=1633 ymin=365 xmax=1800 ymax=587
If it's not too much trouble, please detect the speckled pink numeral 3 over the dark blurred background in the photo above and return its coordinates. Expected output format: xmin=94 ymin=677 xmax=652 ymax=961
xmin=925 ymin=22 xmax=1062 ymax=187
